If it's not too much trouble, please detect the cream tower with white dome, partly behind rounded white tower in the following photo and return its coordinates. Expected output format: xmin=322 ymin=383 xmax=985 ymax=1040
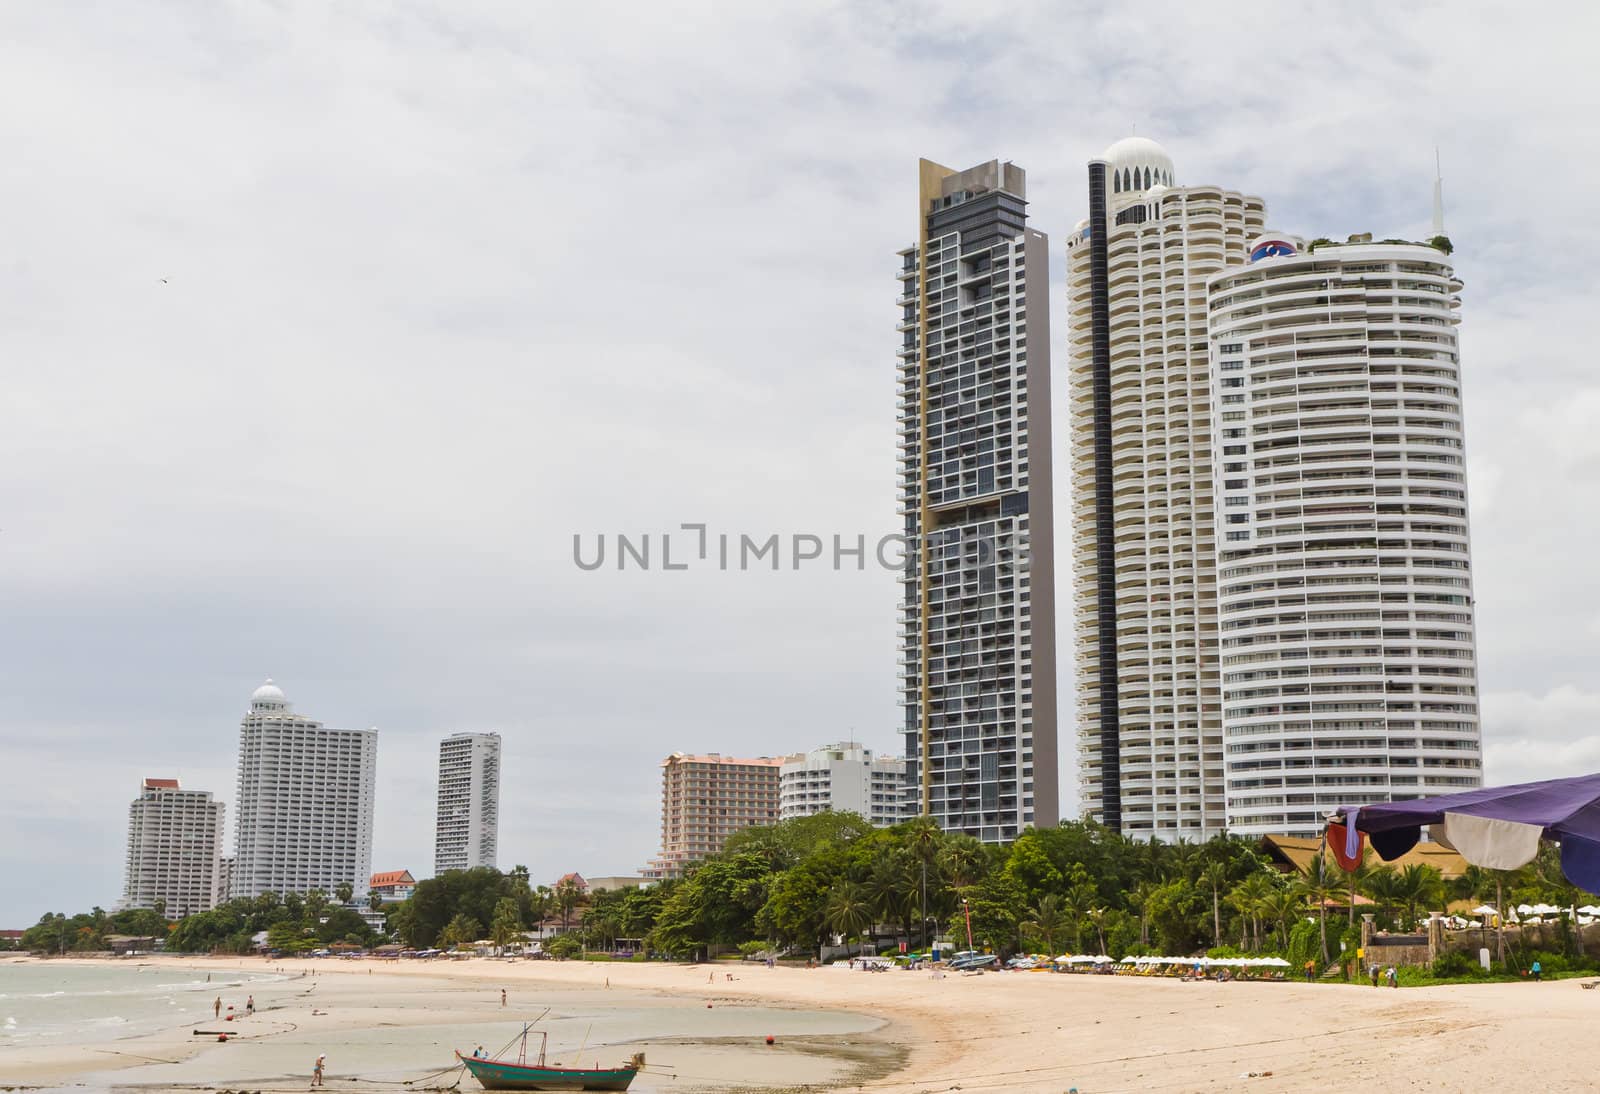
xmin=1067 ymin=138 xmax=1266 ymax=840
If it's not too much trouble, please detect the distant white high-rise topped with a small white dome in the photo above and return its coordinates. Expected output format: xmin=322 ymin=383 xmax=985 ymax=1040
xmin=230 ymin=680 xmax=378 ymax=897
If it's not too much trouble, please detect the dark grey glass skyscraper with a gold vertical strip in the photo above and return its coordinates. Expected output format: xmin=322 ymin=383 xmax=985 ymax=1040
xmin=898 ymin=160 xmax=1059 ymax=843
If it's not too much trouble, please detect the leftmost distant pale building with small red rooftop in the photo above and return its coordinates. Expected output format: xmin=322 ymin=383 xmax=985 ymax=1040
xmin=118 ymin=779 xmax=222 ymax=920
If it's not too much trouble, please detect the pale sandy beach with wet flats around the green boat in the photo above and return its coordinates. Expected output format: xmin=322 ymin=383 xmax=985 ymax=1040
xmin=0 ymin=956 xmax=1600 ymax=1094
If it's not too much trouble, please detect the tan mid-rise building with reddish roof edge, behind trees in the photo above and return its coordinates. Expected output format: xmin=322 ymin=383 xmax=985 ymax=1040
xmin=640 ymin=752 xmax=782 ymax=880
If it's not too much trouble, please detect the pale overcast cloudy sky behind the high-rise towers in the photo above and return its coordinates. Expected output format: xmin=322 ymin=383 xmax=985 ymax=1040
xmin=0 ymin=0 xmax=1600 ymax=926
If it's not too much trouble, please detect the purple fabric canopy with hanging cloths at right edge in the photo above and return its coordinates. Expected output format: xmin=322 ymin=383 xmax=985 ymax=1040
xmin=1339 ymin=774 xmax=1600 ymax=892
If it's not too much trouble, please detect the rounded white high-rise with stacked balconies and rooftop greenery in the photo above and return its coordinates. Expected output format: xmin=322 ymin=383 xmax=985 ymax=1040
xmin=1210 ymin=237 xmax=1482 ymax=836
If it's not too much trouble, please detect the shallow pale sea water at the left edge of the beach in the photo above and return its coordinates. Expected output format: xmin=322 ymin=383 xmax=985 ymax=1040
xmin=0 ymin=958 xmax=288 ymax=1048
